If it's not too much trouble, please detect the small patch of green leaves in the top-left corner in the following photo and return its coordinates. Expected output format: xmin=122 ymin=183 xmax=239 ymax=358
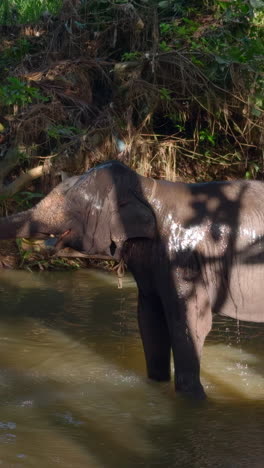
xmin=0 ymin=0 xmax=62 ymax=25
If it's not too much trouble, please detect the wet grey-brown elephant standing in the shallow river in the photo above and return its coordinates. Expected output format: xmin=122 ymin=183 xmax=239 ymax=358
xmin=0 ymin=161 xmax=264 ymax=398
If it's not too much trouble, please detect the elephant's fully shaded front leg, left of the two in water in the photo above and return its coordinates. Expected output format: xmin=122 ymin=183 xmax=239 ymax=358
xmin=138 ymin=293 xmax=171 ymax=382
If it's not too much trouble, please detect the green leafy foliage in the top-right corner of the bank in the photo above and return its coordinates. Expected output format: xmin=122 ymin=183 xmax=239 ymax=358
xmin=159 ymin=0 xmax=264 ymax=81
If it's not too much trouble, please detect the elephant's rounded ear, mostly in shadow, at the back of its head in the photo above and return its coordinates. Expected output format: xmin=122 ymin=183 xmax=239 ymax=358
xmin=110 ymin=198 xmax=156 ymax=249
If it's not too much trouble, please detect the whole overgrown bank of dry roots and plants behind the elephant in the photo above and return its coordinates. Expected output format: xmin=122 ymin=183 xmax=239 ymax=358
xmin=0 ymin=0 xmax=264 ymax=268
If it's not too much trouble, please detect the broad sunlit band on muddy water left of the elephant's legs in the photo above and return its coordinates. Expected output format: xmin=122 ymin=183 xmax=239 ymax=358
xmin=0 ymin=319 xmax=175 ymax=466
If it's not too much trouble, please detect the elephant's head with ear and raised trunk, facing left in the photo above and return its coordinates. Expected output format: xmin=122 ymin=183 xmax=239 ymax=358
xmin=0 ymin=161 xmax=156 ymax=259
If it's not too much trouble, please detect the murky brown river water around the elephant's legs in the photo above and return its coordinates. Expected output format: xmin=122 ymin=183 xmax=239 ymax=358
xmin=0 ymin=271 xmax=264 ymax=468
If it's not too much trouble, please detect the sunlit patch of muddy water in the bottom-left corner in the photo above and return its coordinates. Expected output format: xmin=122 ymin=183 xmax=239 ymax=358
xmin=0 ymin=401 xmax=104 ymax=468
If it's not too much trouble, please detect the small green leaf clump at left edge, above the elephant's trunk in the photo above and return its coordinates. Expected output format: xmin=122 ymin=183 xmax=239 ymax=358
xmin=0 ymin=77 xmax=48 ymax=107
